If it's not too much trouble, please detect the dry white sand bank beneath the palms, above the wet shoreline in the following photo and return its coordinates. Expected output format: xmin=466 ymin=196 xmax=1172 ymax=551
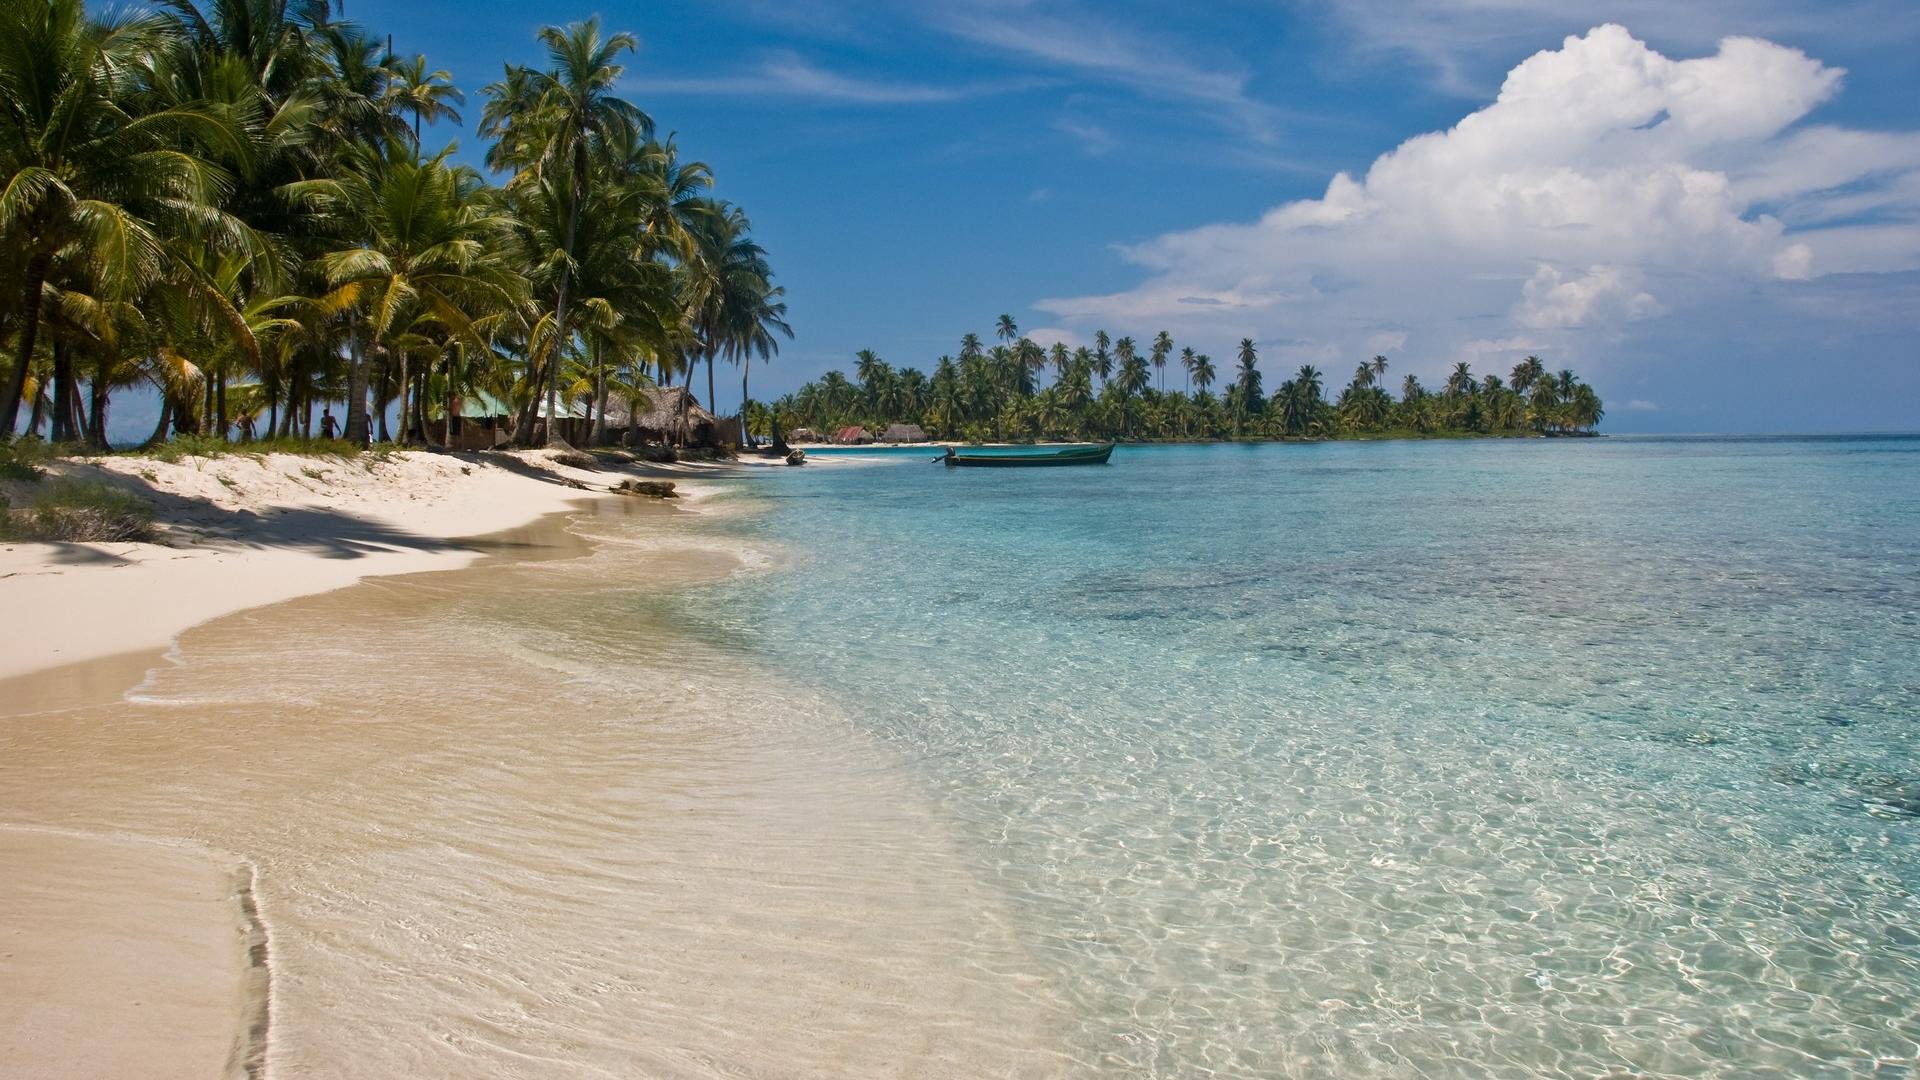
xmin=0 ymin=452 xmax=724 ymax=680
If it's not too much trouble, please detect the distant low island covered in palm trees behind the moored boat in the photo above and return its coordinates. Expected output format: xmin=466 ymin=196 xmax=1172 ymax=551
xmin=764 ymin=315 xmax=1605 ymax=442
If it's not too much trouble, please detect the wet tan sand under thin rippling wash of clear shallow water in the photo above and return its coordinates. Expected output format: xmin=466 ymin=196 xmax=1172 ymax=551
xmin=0 ymin=500 xmax=1071 ymax=1076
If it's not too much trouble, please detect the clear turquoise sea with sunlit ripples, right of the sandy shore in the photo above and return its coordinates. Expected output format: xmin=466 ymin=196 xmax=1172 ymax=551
xmin=674 ymin=438 xmax=1920 ymax=1076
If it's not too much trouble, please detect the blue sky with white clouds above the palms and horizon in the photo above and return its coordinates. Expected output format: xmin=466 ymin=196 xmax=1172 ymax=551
xmin=362 ymin=0 xmax=1920 ymax=430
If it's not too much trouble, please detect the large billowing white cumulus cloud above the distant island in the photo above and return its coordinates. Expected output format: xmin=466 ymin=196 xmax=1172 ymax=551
xmin=1037 ymin=25 xmax=1920 ymax=376
